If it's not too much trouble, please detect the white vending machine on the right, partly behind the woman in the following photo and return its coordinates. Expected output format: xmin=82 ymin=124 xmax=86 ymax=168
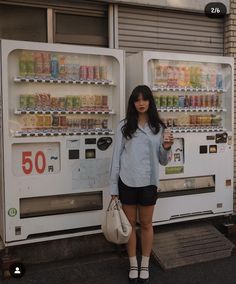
xmin=126 ymin=51 xmax=234 ymax=224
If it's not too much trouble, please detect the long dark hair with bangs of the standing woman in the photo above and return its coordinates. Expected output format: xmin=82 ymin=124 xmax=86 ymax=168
xmin=122 ymin=85 xmax=166 ymax=139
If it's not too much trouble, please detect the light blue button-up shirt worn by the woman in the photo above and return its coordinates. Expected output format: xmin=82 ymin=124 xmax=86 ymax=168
xmin=110 ymin=121 xmax=171 ymax=195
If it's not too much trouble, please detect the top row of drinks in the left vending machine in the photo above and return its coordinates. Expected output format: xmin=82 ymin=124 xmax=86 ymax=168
xmin=19 ymin=51 xmax=108 ymax=81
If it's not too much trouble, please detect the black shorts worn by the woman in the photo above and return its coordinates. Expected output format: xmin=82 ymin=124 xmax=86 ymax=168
xmin=118 ymin=177 xmax=157 ymax=206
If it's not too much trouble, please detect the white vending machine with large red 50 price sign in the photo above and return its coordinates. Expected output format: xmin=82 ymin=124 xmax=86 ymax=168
xmin=0 ymin=40 xmax=124 ymax=246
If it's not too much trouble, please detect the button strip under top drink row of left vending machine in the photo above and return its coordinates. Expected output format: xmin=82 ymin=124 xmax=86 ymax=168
xmin=14 ymin=77 xmax=116 ymax=86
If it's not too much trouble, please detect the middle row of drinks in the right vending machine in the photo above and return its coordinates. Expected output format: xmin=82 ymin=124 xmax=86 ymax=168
xmin=154 ymin=93 xmax=222 ymax=108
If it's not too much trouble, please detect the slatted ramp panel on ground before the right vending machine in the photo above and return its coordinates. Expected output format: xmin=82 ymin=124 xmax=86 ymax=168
xmin=152 ymin=223 xmax=234 ymax=270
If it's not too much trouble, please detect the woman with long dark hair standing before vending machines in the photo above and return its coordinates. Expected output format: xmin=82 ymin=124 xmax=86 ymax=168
xmin=110 ymin=85 xmax=173 ymax=283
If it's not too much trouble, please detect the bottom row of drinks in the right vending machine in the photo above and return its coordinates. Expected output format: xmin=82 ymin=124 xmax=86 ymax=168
xmin=162 ymin=114 xmax=222 ymax=127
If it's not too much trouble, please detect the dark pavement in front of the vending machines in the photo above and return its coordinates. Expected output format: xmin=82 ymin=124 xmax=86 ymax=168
xmin=0 ymin=230 xmax=236 ymax=284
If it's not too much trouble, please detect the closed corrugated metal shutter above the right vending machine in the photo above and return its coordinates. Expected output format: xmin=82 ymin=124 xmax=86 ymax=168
xmin=118 ymin=5 xmax=224 ymax=55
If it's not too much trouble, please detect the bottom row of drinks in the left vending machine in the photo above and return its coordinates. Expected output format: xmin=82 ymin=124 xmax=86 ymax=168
xmin=20 ymin=114 xmax=108 ymax=130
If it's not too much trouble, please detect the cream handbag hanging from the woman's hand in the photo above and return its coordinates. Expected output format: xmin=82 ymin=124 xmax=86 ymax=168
xmin=102 ymin=198 xmax=132 ymax=244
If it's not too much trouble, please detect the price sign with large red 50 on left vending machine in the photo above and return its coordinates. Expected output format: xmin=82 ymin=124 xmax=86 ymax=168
xmin=12 ymin=143 xmax=60 ymax=176
